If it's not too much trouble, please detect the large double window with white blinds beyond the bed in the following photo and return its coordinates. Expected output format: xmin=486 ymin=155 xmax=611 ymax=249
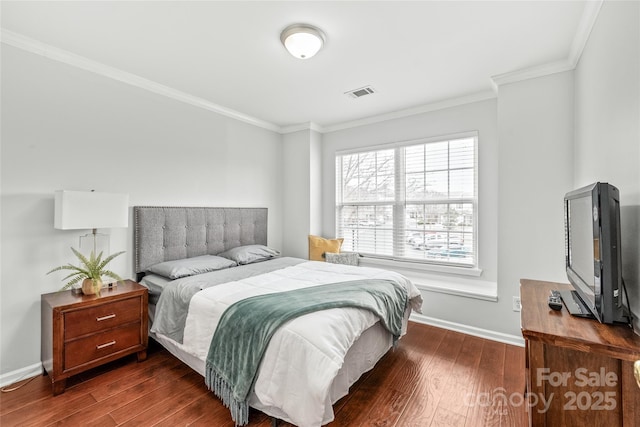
xmin=336 ymin=133 xmax=478 ymax=267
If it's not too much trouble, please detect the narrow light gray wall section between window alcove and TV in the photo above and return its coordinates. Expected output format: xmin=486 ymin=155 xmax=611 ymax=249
xmin=498 ymin=72 xmax=573 ymax=310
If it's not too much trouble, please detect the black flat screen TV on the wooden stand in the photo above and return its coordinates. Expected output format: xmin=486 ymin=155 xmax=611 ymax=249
xmin=562 ymin=182 xmax=629 ymax=323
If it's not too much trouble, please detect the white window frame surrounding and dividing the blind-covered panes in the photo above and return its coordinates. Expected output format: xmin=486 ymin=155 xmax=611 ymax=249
xmin=334 ymin=131 xmax=481 ymax=275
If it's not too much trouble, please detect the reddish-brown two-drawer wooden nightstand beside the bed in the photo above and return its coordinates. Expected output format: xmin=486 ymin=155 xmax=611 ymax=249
xmin=41 ymin=280 xmax=148 ymax=395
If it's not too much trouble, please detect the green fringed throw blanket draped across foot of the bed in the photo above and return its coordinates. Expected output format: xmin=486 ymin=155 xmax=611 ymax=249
xmin=205 ymin=279 xmax=408 ymax=425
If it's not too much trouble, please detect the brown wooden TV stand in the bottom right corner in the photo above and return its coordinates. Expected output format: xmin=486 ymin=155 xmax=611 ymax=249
xmin=520 ymin=279 xmax=640 ymax=427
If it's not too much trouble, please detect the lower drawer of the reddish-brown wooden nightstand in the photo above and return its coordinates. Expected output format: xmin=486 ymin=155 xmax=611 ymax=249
xmin=64 ymin=322 xmax=142 ymax=371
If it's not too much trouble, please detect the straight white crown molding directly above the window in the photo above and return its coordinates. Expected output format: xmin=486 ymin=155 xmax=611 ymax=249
xmin=322 ymin=90 xmax=496 ymax=133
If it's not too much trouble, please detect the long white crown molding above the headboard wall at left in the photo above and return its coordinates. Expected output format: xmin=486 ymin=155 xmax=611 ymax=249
xmin=1 ymin=28 xmax=280 ymax=132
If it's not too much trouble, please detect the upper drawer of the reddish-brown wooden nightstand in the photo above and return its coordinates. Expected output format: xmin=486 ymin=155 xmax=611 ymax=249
xmin=64 ymin=297 xmax=142 ymax=341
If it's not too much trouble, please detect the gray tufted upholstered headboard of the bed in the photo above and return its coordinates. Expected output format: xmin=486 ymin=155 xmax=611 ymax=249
xmin=133 ymin=206 xmax=267 ymax=275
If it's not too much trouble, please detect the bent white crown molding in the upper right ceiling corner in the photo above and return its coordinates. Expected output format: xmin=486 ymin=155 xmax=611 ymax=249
xmin=491 ymin=0 xmax=604 ymax=93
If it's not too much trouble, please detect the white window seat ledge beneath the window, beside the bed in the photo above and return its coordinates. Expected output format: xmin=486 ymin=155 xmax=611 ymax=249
xmin=360 ymin=258 xmax=498 ymax=301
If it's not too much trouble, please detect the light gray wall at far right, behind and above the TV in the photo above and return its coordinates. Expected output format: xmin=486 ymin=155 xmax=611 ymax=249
xmin=574 ymin=1 xmax=640 ymax=330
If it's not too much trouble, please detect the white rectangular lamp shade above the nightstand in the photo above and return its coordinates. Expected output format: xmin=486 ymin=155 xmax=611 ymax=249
xmin=54 ymin=190 xmax=129 ymax=230
